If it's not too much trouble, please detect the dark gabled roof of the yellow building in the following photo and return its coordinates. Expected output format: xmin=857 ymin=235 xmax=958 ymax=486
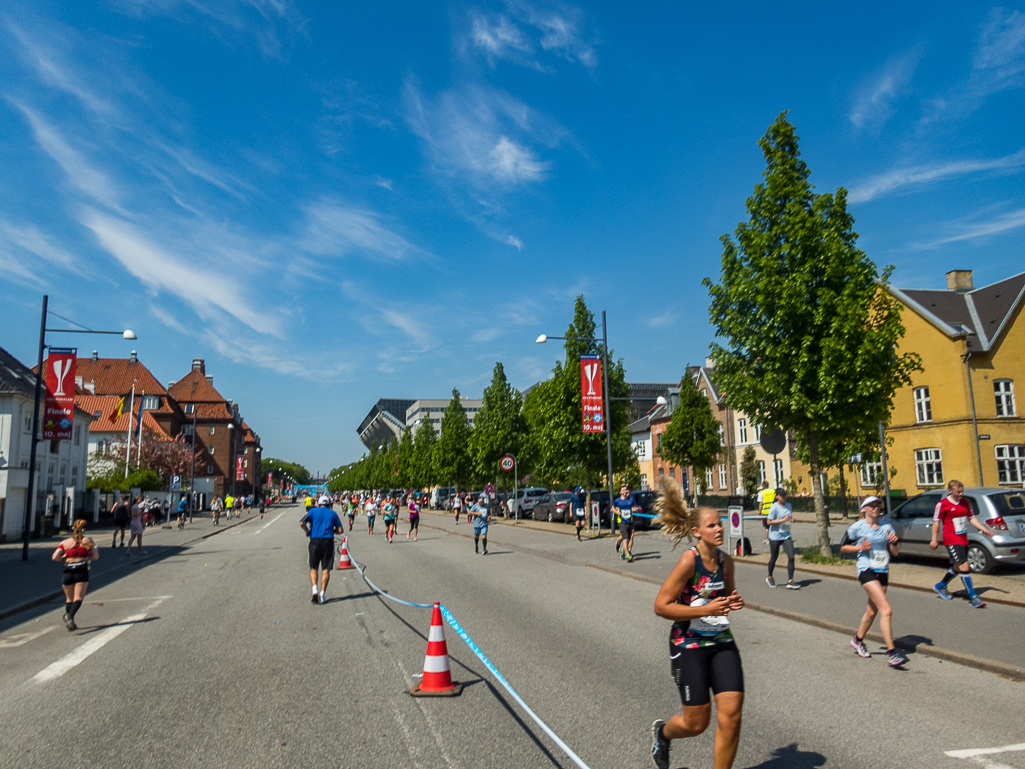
xmin=890 ymin=273 xmax=1025 ymax=352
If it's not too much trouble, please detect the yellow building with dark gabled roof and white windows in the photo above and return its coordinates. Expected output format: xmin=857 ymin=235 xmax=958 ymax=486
xmin=881 ymin=270 xmax=1025 ymax=496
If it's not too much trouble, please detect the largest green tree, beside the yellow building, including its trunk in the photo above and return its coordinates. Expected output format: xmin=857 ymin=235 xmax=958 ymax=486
xmin=704 ymin=113 xmax=920 ymax=556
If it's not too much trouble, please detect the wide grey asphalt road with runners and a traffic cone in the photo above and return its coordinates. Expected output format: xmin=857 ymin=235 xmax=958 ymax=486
xmin=0 ymin=509 xmax=1025 ymax=769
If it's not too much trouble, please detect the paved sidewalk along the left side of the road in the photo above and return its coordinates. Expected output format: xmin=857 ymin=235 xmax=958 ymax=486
xmin=0 ymin=505 xmax=292 ymax=619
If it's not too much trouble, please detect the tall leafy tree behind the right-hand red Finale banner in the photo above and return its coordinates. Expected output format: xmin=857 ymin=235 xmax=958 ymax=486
xmin=524 ymin=294 xmax=637 ymax=508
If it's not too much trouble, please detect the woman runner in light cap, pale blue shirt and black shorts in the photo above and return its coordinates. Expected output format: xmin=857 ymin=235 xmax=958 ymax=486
xmin=839 ymin=496 xmax=907 ymax=667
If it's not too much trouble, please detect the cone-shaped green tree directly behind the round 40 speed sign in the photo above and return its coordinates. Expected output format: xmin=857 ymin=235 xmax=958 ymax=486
xmin=469 ymin=363 xmax=527 ymax=486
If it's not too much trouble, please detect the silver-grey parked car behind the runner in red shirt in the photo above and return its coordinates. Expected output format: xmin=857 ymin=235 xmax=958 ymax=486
xmin=890 ymin=487 xmax=1025 ymax=574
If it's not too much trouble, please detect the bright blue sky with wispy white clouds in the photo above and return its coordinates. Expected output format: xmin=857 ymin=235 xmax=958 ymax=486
xmin=0 ymin=0 xmax=1025 ymax=471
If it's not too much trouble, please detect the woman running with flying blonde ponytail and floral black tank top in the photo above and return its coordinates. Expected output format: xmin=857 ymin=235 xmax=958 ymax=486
xmin=651 ymin=479 xmax=744 ymax=769
